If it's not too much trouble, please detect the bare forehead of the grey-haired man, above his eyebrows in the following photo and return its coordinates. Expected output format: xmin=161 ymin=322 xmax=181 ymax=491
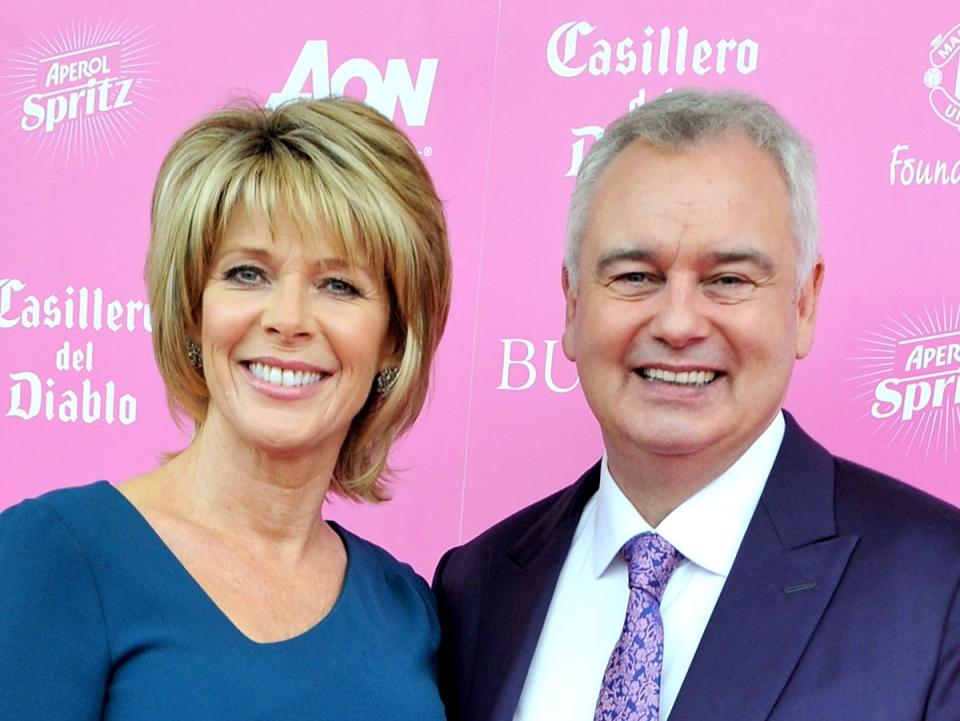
xmin=581 ymin=135 xmax=795 ymax=278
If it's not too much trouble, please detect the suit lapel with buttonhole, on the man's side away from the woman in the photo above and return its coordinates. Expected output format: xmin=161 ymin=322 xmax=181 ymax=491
xmin=670 ymin=414 xmax=858 ymax=721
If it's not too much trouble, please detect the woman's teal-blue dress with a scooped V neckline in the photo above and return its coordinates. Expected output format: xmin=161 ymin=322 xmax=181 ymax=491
xmin=0 ymin=481 xmax=444 ymax=721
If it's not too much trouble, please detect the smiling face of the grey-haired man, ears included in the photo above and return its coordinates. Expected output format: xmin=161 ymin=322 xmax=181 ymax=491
xmin=563 ymin=135 xmax=823 ymax=475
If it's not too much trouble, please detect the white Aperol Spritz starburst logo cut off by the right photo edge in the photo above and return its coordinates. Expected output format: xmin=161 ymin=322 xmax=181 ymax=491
xmin=849 ymin=301 xmax=960 ymax=460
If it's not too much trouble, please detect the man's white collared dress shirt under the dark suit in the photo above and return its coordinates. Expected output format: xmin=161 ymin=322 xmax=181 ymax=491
xmin=513 ymin=413 xmax=784 ymax=721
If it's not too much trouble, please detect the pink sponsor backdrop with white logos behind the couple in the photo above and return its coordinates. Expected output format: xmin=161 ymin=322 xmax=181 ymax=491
xmin=0 ymin=0 xmax=960 ymax=574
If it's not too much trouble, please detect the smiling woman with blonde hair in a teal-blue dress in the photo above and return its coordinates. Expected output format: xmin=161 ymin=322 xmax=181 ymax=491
xmin=0 ymin=99 xmax=450 ymax=721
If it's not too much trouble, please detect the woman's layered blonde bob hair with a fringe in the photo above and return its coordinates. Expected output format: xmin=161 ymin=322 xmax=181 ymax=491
xmin=146 ymin=98 xmax=451 ymax=501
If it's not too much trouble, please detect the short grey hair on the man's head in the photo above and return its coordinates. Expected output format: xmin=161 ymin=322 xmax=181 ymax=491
xmin=563 ymin=90 xmax=820 ymax=292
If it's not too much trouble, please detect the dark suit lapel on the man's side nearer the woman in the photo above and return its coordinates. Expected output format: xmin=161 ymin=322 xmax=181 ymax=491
xmin=469 ymin=464 xmax=600 ymax=721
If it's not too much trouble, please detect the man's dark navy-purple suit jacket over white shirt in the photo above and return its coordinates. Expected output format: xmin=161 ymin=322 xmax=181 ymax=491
xmin=434 ymin=416 xmax=960 ymax=721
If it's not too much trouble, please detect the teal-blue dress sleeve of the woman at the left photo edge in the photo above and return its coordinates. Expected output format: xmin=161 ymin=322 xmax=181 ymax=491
xmin=0 ymin=501 xmax=110 ymax=721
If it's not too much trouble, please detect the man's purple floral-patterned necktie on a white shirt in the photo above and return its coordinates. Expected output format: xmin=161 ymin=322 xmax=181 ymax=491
xmin=593 ymin=533 xmax=683 ymax=721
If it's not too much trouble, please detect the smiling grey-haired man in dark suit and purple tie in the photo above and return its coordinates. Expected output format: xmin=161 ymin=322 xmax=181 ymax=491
xmin=434 ymin=91 xmax=960 ymax=721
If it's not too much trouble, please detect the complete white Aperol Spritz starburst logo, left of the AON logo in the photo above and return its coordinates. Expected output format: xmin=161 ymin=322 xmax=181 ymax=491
xmin=5 ymin=21 xmax=156 ymax=162
